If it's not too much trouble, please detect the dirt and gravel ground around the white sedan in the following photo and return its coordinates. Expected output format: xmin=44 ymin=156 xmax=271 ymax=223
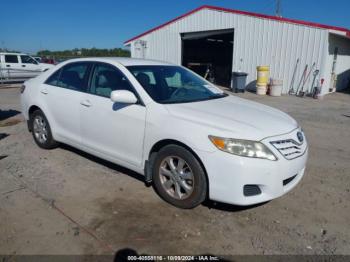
xmin=0 ymin=88 xmax=350 ymax=255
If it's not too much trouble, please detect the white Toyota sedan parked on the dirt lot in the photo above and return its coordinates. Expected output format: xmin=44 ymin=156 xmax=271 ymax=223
xmin=21 ymin=58 xmax=308 ymax=208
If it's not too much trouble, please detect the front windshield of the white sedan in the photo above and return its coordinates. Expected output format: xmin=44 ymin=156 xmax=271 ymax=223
xmin=127 ymin=66 xmax=227 ymax=104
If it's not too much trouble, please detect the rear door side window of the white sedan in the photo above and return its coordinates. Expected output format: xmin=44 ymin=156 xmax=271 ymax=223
xmin=57 ymin=63 xmax=90 ymax=92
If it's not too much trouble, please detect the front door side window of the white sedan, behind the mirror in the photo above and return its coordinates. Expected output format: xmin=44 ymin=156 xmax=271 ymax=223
xmin=90 ymin=64 xmax=133 ymax=98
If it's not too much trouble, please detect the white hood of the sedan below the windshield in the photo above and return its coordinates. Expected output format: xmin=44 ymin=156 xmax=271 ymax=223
xmin=165 ymin=95 xmax=298 ymax=140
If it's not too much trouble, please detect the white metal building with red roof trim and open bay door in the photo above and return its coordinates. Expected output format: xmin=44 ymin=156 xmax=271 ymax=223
xmin=125 ymin=6 xmax=350 ymax=94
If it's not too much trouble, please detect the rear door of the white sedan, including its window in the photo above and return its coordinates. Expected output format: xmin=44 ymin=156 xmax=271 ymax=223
xmin=40 ymin=62 xmax=92 ymax=144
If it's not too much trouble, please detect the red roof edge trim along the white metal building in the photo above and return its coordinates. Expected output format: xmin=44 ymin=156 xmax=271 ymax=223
xmin=124 ymin=5 xmax=350 ymax=44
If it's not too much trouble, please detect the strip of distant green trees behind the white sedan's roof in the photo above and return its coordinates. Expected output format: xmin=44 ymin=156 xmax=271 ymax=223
xmin=37 ymin=47 xmax=130 ymax=58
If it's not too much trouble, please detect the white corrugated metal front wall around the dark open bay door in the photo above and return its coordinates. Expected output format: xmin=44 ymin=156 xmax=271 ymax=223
xmin=131 ymin=9 xmax=328 ymax=93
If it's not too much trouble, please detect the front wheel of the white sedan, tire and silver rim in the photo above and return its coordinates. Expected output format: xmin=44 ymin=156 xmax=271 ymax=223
xmin=152 ymin=145 xmax=208 ymax=209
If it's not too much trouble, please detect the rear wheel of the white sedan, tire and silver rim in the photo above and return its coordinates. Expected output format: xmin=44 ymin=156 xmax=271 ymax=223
xmin=30 ymin=110 xmax=58 ymax=149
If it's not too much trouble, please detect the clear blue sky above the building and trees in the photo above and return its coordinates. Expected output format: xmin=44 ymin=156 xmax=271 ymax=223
xmin=0 ymin=0 xmax=350 ymax=54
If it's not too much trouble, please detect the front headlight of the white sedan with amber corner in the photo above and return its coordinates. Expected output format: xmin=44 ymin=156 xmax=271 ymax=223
xmin=209 ymin=136 xmax=277 ymax=161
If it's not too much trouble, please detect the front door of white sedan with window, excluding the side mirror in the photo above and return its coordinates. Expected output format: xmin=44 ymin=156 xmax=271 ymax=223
xmin=80 ymin=63 xmax=146 ymax=167
